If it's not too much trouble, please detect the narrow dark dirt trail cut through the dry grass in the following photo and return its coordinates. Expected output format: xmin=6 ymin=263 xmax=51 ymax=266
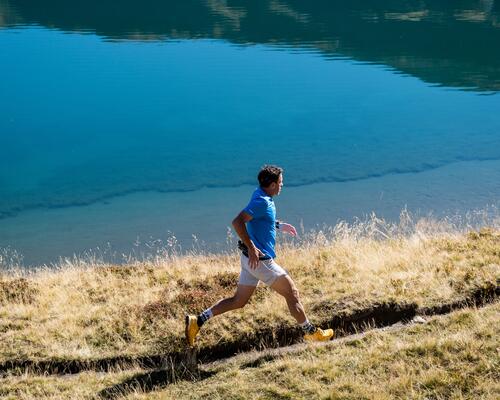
xmin=0 ymin=285 xmax=500 ymax=376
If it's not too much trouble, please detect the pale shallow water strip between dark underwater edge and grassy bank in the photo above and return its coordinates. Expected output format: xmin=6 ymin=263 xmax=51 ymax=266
xmin=0 ymin=160 xmax=500 ymax=268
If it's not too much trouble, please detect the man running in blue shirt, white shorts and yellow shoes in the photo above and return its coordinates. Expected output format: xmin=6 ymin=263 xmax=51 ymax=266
xmin=186 ymin=165 xmax=333 ymax=346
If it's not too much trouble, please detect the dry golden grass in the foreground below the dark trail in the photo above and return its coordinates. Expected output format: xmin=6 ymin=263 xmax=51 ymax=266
xmin=0 ymin=303 xmax=500 ymax=400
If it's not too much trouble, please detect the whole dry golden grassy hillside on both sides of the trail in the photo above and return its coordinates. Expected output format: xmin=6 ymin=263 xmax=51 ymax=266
xmin=0 ymin=218 xmax=500 ymax=399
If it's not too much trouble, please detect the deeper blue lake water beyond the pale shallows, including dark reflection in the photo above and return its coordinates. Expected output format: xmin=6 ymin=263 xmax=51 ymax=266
xmin=0 ymin=0 xmax=500 ymax=217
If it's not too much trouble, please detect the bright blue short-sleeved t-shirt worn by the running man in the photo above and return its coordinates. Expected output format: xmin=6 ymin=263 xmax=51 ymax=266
xmin=243 ymin=187 xmax=276 ymax=258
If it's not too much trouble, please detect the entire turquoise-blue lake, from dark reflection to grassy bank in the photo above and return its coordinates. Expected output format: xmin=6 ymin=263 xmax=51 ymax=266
xmin=0 ymin=0 xmax=500 ymax=265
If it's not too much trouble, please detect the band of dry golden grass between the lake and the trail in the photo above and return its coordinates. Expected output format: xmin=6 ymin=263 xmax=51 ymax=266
xmin=0 ymin=214 xmax=500 ymax=362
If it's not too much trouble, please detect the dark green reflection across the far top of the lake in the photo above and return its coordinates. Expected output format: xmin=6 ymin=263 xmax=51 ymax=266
xmin=0 ymin=0 xmax=500 ymax=91
